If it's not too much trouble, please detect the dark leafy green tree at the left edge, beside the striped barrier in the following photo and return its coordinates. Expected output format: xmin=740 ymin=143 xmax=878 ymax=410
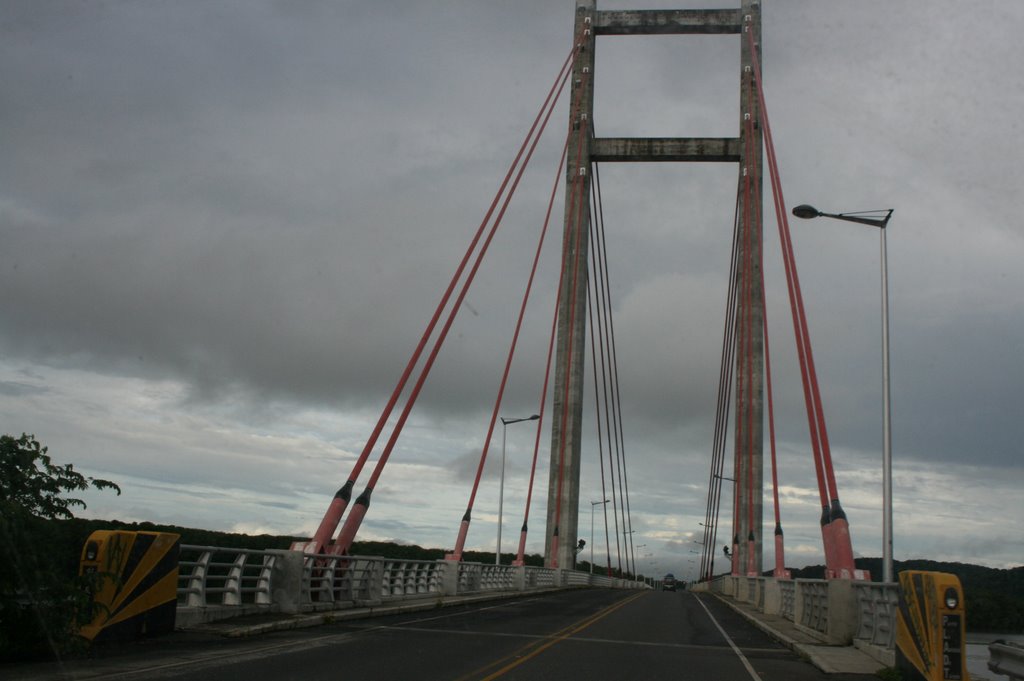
xmin=0 ymin=433 xmax=121 ymax=659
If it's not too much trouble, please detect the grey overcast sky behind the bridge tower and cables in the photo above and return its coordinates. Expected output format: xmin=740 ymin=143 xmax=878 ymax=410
xmin=0 ymin=0 xmax=1024 ymax=577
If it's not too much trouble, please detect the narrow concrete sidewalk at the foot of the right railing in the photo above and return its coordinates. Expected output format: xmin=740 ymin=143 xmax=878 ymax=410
xmin=715 ymin=594 xmax=886 ymax=674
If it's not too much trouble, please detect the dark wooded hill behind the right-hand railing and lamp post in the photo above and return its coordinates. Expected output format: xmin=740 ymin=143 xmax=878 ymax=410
xmin=793 ymin=558 xmax=1024 ymax=634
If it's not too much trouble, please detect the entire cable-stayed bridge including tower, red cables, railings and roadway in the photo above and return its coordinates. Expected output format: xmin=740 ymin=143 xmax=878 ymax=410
xmin=46 ymin=0 xmax=974 ymax=679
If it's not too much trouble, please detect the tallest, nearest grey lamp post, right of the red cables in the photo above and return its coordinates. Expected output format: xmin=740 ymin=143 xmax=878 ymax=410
xmin=793 ymin=204 xmax=893 ymax=582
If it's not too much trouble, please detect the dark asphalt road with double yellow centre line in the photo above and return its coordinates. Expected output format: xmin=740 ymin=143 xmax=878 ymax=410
xmin=8 ymin=589 xmax=877 ymax=681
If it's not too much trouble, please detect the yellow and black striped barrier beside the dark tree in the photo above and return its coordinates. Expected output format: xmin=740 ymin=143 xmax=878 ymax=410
xmin=79 ymin=529 xmax=180 ymax=641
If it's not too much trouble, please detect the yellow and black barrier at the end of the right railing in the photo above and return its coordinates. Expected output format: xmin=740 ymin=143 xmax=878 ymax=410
xmin=896 ymin=570 xmax=969 ymax=681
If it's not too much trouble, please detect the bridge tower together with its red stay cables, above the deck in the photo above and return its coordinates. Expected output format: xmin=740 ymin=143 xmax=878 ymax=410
xmin=293 ymin=0 xmax=867 ymax=579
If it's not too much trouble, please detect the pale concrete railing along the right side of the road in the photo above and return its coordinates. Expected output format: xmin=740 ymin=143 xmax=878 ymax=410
xmin=707 ymin=576 xmax=899 ymax=666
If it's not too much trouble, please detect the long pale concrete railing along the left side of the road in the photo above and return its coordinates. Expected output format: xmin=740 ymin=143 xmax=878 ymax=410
xmin=177 ymin=545 xmax=648 ymax=627
